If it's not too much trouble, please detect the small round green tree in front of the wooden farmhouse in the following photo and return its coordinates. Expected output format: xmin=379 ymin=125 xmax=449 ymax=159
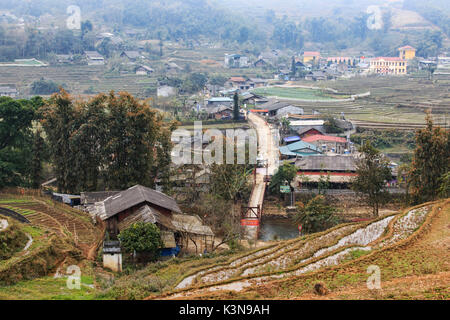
xmin=118 ymin=222 xmax=163 ymax=259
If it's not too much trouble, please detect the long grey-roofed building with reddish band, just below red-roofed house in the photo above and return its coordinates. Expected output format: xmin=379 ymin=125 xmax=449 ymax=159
xmin=292 ymin=155 xmax=357 ymax=189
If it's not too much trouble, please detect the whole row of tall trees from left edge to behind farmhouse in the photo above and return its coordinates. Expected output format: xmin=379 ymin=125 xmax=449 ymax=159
xmin=0 ymin=90 xmax=176 ymax=193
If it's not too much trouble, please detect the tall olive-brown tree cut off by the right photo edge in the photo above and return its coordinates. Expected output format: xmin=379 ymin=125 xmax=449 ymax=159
xmin=409 ymin=113 xmax=450 ymax=203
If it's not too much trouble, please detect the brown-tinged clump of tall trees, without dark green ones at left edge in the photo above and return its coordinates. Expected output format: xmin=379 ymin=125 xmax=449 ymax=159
xmin=41 ymin=91 xmax=175 ymax=193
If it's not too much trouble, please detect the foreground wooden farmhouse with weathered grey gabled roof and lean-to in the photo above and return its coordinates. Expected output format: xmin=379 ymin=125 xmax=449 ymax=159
xmin=90 ymin=185 xmax=214 ymax=255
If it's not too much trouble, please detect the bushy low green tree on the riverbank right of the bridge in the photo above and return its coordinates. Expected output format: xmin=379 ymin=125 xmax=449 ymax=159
xmin=293 ymin=195 xmax=339 ymax=233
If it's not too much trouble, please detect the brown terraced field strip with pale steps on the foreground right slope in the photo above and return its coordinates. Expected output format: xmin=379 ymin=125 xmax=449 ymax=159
xmin=158 ymin=201 xmax=450 ymax=299
